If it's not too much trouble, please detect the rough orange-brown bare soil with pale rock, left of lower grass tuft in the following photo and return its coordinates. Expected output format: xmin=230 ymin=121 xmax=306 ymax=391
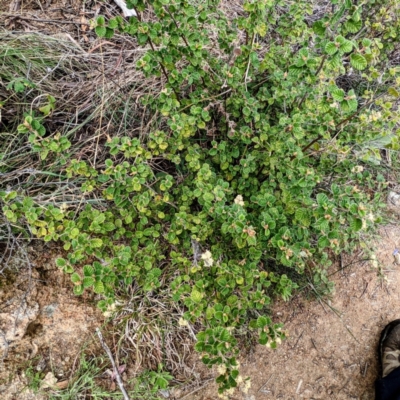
xmin=0 ymin=244 xmax=104 ymax=400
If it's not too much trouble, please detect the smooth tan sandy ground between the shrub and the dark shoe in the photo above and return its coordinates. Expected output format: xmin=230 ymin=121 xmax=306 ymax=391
xmin=184 ymin=226 xmax=400 ymax=400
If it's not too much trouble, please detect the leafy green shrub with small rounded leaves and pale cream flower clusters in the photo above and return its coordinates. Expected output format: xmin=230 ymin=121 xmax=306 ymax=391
xmin=3 ymin=0 xmax=400 ymax=391
